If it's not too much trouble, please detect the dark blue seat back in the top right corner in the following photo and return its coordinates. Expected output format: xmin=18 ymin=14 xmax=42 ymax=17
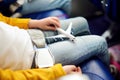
xmin=102 ymin=0 xmax=120 ymax=21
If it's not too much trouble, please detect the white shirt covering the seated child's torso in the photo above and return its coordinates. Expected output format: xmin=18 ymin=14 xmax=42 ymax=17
xmin=0 ymin=22 xmax=35 ymax=70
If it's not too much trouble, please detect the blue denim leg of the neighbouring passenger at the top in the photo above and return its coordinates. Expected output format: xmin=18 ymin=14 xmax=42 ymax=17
xmin=19 ymin=0 xmax=72 ymax=15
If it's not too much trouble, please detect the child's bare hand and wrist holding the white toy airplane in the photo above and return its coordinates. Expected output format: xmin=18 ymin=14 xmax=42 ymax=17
xmin=29 ymin=17 xmax=60 ymax=30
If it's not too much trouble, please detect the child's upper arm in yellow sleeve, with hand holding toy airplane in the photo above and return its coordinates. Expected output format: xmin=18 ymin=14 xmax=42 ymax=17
xmin=0 ymin=14 xmax=60 ymax=30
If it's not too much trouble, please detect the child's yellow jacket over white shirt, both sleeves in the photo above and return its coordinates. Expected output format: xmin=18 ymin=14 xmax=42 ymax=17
xmin=0 ymin=14 xmax=66 ymax=80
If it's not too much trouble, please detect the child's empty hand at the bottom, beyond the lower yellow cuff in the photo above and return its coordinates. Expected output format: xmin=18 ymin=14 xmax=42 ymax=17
xmin=63 ymin=65 xmax=82 ymax=74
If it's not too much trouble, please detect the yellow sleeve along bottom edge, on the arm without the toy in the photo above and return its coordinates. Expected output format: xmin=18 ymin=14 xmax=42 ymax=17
xmin=0 ymin=64 xmax=66 ymax=80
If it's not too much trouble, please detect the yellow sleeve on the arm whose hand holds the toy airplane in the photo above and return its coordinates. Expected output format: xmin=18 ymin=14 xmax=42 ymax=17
xmin=0 ymin=13 xmax=30 ymax=29
